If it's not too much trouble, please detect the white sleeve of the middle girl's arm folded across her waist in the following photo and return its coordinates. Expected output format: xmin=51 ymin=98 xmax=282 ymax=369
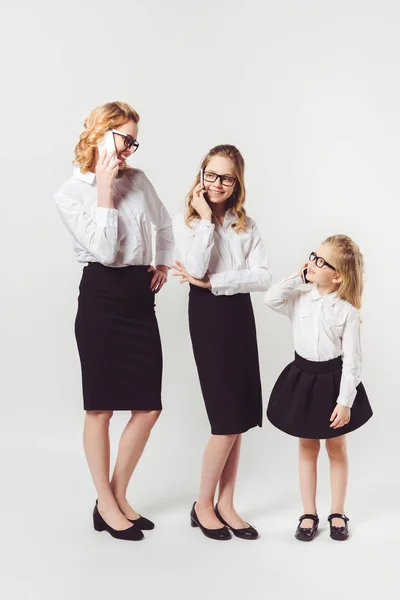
xmin=209 ymin=222 xmax=272 ymax=296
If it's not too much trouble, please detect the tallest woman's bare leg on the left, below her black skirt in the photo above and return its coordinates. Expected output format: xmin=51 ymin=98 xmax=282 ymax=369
xmin=83 ymin=411 xmax=132 ymax=530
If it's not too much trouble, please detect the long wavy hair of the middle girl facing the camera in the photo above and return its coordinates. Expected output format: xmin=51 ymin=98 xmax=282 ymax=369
xmin=185 ymin=144 xmax=247 ymax=233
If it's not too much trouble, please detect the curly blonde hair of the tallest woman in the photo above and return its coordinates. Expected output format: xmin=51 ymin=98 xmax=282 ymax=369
xmin=74 ymin=102 xmax=139 ymax=172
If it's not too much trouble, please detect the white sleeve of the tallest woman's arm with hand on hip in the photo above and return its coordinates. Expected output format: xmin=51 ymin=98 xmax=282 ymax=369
xmin=144 ymin=175 xmax=174 ymax=267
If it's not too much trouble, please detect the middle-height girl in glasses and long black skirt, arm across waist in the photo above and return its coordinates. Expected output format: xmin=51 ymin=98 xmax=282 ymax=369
xmin=173 ymin=145 xmax=271 ymax=540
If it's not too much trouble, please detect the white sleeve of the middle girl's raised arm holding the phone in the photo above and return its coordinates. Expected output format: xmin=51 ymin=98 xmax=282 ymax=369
xmin=173 ymin=213 xmax=215 ymax=279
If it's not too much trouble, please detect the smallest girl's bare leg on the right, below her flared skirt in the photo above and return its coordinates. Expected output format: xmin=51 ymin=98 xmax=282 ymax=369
xmin=326 ymin=435 xmax=349 ymax=527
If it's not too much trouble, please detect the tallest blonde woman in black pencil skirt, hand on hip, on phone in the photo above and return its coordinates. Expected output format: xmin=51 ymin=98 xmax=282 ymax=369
xmin=56 ymin=102 xmax=173 ymax=540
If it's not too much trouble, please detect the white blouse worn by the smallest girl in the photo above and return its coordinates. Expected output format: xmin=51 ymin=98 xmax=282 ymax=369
xmin=264 ymin=273 xmax=362 ymax=408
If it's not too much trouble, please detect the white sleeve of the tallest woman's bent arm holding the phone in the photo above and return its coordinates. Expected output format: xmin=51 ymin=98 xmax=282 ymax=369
xmin=55 ymin=189 xmax=118 ymax=265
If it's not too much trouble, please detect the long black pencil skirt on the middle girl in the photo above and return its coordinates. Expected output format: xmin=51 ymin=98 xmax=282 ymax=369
xmin=189 ymin=285 xmax=262 ymax=435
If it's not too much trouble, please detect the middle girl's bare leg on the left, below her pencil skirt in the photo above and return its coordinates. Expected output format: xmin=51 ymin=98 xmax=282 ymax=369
xmin=195 ymin=434 xmax=237 ymax=529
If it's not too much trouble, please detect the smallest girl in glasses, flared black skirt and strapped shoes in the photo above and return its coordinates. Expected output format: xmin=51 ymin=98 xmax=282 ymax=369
xmin=265 ymin=235 xmax=372 ymax=541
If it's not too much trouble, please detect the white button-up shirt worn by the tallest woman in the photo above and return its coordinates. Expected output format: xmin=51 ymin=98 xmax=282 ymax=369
xmin=55 ymin=167 xmax=173 ymax=267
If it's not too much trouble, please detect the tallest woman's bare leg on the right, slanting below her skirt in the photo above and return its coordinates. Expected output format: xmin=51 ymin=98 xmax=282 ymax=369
xmin=111 ymin=410 xmax=161 ymax=519
